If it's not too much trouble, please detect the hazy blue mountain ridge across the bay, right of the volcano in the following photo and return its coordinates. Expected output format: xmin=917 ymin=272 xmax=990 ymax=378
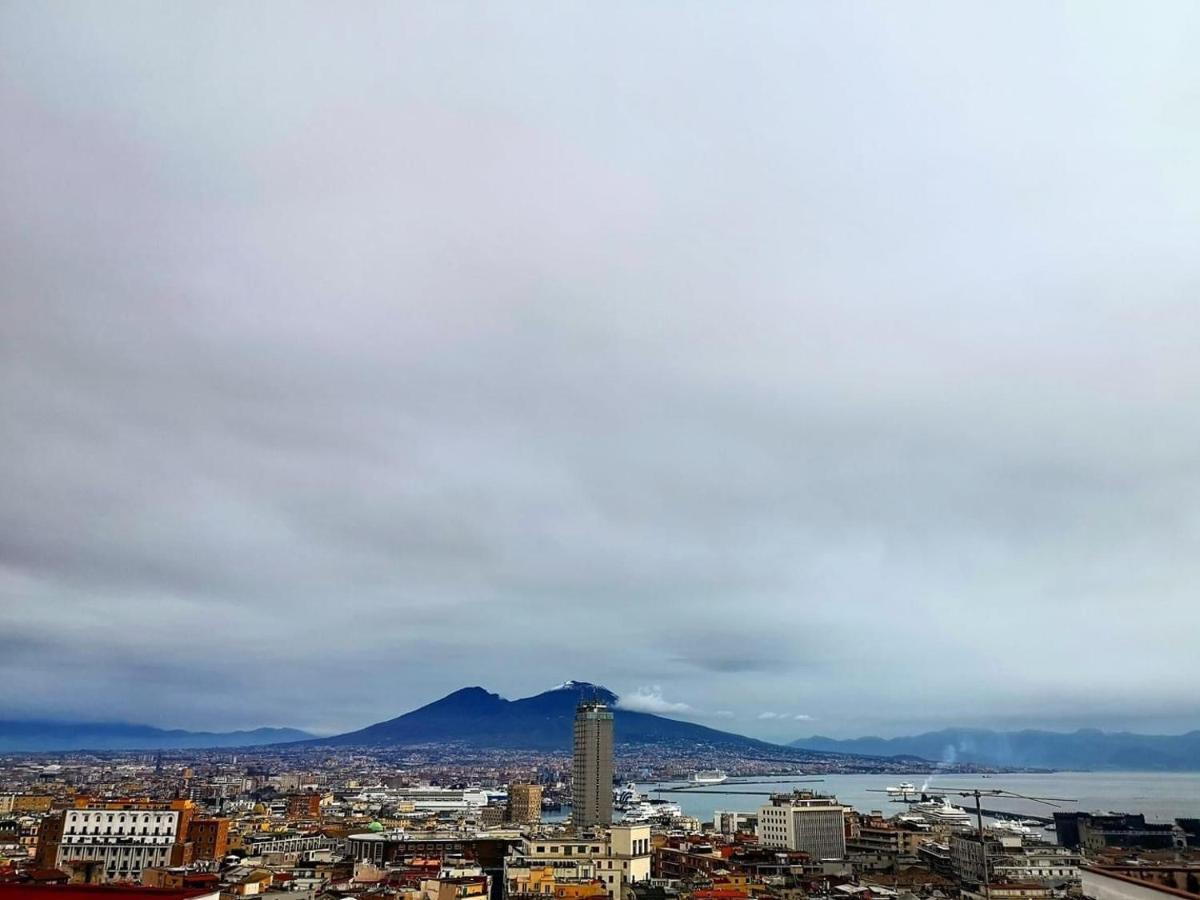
xmin=791 ymin=728 xmax=1200 ymax=772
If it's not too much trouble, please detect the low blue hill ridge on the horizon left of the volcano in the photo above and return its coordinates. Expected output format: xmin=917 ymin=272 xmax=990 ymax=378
xmin=0 ymin=720 xmax=312 ymax=752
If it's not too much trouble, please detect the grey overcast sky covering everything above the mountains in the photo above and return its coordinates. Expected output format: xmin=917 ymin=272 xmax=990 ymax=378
xmin=0 ymin=0 xmax=1200 ymax=739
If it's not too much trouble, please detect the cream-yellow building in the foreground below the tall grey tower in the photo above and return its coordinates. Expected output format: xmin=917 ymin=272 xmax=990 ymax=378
xmin=505 ymin=824 xmax=650 ymax=900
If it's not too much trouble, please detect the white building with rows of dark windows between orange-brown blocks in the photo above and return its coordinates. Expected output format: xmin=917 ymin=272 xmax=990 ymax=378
xmin=55 ymin=809 xmax=180 ymax=881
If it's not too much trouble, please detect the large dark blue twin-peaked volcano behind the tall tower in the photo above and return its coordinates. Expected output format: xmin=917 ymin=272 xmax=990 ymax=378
xmin=307 ymin=682 xmax=907 ymax=766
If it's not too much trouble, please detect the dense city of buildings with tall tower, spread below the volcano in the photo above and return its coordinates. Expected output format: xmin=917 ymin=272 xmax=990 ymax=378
xmin=0 ymin=701 xmax=1200 ymax=900
